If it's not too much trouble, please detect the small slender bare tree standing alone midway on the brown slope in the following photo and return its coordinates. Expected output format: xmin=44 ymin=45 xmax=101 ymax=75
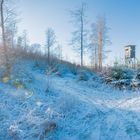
xmin=46 ymin=28 xmax=56 ymax=64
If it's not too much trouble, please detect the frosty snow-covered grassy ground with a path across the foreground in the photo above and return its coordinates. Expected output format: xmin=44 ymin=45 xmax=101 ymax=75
xmin=0 ymin=60 xmax=140 ymax=140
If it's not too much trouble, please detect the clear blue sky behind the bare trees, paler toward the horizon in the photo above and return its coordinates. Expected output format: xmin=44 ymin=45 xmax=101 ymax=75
xmin=18 ymin=0 xmax=140 ymax=64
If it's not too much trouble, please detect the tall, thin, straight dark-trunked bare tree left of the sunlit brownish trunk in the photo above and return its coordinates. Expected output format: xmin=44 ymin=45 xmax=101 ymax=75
xmin=71 ymin=3 xmax=87 ymax=66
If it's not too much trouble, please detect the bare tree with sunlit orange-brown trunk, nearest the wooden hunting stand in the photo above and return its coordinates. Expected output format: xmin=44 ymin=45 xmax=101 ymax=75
xmin=91 ymin=17 xmax=110 ymax=70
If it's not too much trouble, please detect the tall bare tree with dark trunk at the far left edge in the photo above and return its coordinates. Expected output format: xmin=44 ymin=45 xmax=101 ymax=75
xmin=0 ymin=0 xmax=16 ymax=75
